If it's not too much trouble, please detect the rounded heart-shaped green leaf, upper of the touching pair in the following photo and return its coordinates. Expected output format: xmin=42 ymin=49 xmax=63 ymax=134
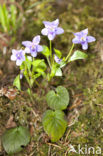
xmin=46 ymin=86 xmax=69 ymax=110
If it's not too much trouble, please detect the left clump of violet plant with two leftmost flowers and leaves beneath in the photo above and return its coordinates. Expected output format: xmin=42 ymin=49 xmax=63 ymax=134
xmin=11 ymin=35 xmax=46 ymax=96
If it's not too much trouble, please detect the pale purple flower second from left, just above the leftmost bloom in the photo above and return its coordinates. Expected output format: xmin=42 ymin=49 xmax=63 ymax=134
xmin=22 ymin=35 xmax=43 ymax=57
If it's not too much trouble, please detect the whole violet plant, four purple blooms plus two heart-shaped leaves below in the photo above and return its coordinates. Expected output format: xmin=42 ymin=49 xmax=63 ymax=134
xmin=11 ymin=19 xmax=96 ymax=142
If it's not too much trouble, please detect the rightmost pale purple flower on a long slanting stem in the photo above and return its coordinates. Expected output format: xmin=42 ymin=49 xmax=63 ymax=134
xmin=72 ymin=28 xmax=96 ymax=50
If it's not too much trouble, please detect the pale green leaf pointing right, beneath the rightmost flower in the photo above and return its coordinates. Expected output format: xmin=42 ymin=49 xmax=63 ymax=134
xmin=68 ymin=50 xmax=88 ymax=62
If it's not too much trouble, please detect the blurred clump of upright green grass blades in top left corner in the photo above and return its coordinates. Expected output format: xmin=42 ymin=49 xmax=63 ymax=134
xmin=0 ymin=0 xmax=21 ymax=34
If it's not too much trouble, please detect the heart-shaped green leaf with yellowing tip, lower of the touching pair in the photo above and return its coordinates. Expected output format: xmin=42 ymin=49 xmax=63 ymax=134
xmin=42 ymin=110 xmax=67 ymax=142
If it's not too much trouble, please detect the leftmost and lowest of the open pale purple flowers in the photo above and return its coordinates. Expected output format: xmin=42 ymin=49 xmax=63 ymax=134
xmin=11 ymin=49 xmax=25 ymax=66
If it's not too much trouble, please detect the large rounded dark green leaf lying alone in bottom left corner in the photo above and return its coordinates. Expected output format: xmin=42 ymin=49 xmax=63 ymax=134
xmin=2 ymin=126 xmax=30 ymax=154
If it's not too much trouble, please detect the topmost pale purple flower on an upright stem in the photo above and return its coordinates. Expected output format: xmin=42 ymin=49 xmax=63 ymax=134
xmin=41 ymin=19 xmax=64 ymax=40
